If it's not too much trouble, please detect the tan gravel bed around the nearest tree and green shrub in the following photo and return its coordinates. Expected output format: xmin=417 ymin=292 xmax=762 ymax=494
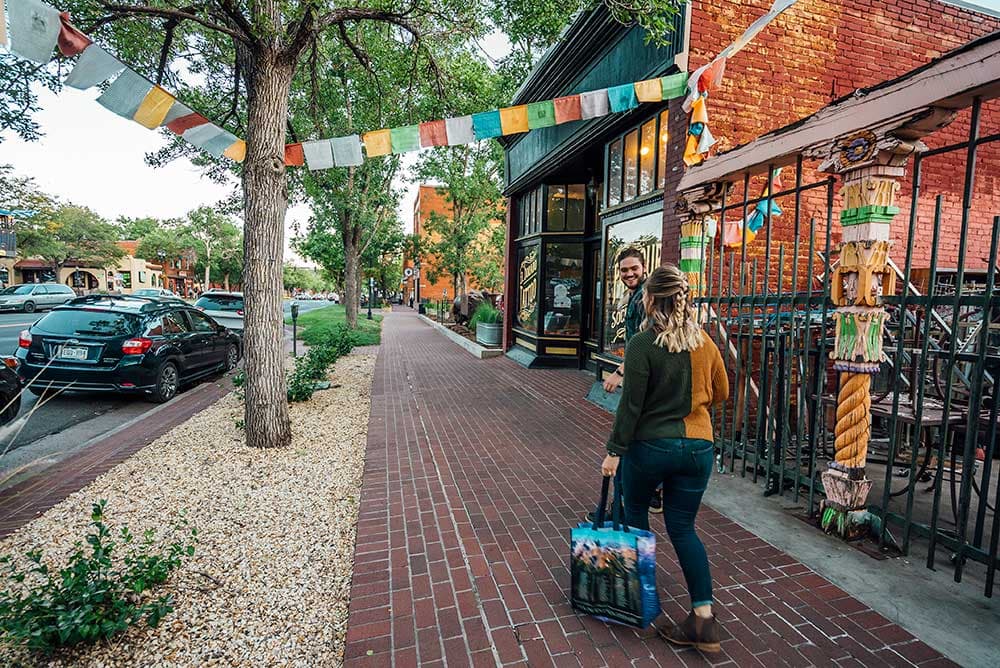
xmin=0 ymin=354 xmax=375 ymax=667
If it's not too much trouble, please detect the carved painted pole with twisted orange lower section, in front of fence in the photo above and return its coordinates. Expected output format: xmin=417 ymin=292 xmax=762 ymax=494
xmin=820 ymin=132 xmax=923 ymax=539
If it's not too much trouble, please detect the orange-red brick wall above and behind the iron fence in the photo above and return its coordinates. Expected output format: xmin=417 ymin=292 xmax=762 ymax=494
xmin=664 ymin=0 xmax=1000 ymax=289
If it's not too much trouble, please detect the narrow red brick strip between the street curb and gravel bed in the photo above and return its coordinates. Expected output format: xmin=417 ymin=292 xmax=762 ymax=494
xmin=0 ymin=378 xmax=233 ymax=538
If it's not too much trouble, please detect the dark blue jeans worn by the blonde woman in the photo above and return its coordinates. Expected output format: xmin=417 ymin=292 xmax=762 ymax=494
xmin=619 ymin=438 xmax=715 ymax=608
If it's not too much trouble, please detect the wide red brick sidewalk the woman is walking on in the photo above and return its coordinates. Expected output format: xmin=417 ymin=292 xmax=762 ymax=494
xmin=345 ymin=312 xmax=954 ymax=667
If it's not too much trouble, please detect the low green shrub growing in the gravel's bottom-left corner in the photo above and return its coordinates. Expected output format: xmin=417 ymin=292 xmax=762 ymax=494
xmin=0 ymin=499 xmax=198 ymax=653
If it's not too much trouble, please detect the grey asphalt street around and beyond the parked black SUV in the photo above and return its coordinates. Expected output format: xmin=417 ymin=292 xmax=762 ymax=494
xmin=0 ymin=300 xmax=330 ymax=487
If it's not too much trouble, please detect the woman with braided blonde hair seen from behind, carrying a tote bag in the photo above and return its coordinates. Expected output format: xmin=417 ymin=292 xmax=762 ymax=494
xmin=601 ymin=265 xmax=729 ymax=652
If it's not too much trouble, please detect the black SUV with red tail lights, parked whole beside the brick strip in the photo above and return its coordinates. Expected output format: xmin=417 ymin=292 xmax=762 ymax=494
xmin=17 ymin=295 xmax=241 ymax=402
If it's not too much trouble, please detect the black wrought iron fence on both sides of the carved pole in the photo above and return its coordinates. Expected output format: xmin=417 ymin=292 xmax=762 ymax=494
xmin=698 ymin=99 xmax=1000 ymax=596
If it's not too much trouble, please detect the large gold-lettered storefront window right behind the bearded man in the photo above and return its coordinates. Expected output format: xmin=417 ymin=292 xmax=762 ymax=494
xmin=604 ymin=212 xmax=663 ymax=357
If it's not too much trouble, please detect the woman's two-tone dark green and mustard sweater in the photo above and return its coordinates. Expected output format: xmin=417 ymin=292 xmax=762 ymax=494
xmin=607 ymin=329 xmax=729 ymax=455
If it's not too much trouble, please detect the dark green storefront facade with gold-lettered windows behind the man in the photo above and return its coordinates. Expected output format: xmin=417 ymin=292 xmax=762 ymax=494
xmin=502 ymin=6 xmax=686 ymax=371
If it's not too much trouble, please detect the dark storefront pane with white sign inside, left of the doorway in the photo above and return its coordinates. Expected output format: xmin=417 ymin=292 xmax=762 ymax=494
xmin=542 ymin=244 xmax=583 ymax=336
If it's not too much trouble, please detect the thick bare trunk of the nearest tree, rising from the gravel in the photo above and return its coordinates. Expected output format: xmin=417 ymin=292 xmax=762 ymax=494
xmin=243 ymin=47 xmax=292 ymax=448
